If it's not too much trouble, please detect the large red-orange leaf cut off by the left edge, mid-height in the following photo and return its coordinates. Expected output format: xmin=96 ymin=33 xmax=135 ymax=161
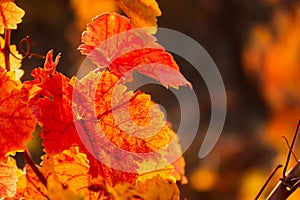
xmin=0 ymin=68 xmax=36 ymax=161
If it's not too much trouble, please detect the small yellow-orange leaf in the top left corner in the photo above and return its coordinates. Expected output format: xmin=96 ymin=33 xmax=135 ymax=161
xmin=0 ymin=0 xmax=25 ymax=34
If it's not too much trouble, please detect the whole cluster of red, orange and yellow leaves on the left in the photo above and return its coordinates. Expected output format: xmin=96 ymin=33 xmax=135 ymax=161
xmin=0 ymin=0 xmax=190 ymax=199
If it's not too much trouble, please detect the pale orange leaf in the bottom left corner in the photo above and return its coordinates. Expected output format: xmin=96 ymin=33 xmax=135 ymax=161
xmin=0 ymin=158 xmax=18 ymax=199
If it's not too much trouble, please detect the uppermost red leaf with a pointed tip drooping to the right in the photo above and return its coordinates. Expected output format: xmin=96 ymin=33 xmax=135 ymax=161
xmin=79 ymin=13 xmax=191 ymax=88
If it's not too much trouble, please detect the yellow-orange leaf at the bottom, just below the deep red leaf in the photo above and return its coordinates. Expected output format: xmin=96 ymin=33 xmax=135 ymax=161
xmin=41 ymin=147 xmax=135 ymax=200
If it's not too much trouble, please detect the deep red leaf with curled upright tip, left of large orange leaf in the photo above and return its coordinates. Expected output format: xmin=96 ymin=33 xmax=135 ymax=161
xmin=23 ymin=51 xmax=80 ymax=155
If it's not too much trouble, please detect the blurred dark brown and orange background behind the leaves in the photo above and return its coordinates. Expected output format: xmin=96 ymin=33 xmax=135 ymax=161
xmin=12 ymin=0 xmax=300 ymax=200
